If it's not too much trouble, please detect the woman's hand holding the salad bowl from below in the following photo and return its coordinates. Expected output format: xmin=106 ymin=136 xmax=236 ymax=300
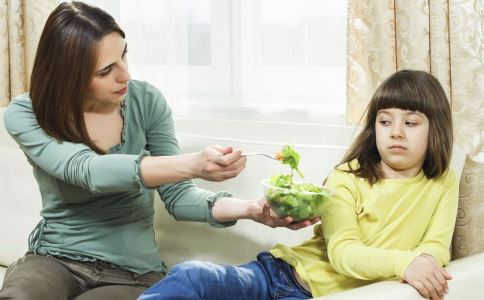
xmin=247 ymin=199 xmax=319 ymax=230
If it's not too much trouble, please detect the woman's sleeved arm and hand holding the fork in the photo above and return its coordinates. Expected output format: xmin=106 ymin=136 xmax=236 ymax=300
xmin=4 ymin=94 xmax=246 ymax=193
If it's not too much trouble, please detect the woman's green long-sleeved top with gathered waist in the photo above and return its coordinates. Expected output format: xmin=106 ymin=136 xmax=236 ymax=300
xmin=4 ymin=80 xmax=233 ymax=274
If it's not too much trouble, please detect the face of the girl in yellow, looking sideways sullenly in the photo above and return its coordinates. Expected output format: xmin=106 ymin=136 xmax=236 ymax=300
xmin=375 ymin=108 xmax=429 ymax=178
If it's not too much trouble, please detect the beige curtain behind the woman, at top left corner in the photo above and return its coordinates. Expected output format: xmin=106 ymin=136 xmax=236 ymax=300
xmin=0 ymin=0 xmax=59 ymax=106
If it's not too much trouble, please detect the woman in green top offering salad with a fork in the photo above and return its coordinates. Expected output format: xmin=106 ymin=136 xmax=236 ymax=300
xmin=0 ymin=2 xmax=316 ymax=299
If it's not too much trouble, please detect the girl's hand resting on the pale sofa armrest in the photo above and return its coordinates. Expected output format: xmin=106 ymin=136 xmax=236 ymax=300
xmin=403 ymin=254 xmax=452 ymax=300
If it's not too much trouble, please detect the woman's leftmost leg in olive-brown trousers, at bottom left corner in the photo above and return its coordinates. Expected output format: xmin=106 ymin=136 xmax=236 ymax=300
xmin=0 ymin=254 xmax=81 ymax=300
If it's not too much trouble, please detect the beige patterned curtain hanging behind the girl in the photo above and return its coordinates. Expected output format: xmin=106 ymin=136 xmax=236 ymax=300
xmin=347 ymin=0 xmax=484 ymax=259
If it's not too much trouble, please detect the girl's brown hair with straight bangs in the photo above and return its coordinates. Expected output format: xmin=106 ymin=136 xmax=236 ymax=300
xmin=342 ymin=70 xmax=453 ymax=184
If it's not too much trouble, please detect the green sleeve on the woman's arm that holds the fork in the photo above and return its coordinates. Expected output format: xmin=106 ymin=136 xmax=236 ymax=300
xmin=4 ymin=94 xmax=142 ymax=193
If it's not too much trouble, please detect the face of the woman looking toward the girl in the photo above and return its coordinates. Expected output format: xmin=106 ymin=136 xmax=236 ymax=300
xmin=85 ymin=32 xmax=131 ymax=111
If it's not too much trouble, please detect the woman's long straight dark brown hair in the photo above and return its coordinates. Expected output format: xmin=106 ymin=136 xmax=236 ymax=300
xmin=30 ymin=2 xmax=125 ymax=154
